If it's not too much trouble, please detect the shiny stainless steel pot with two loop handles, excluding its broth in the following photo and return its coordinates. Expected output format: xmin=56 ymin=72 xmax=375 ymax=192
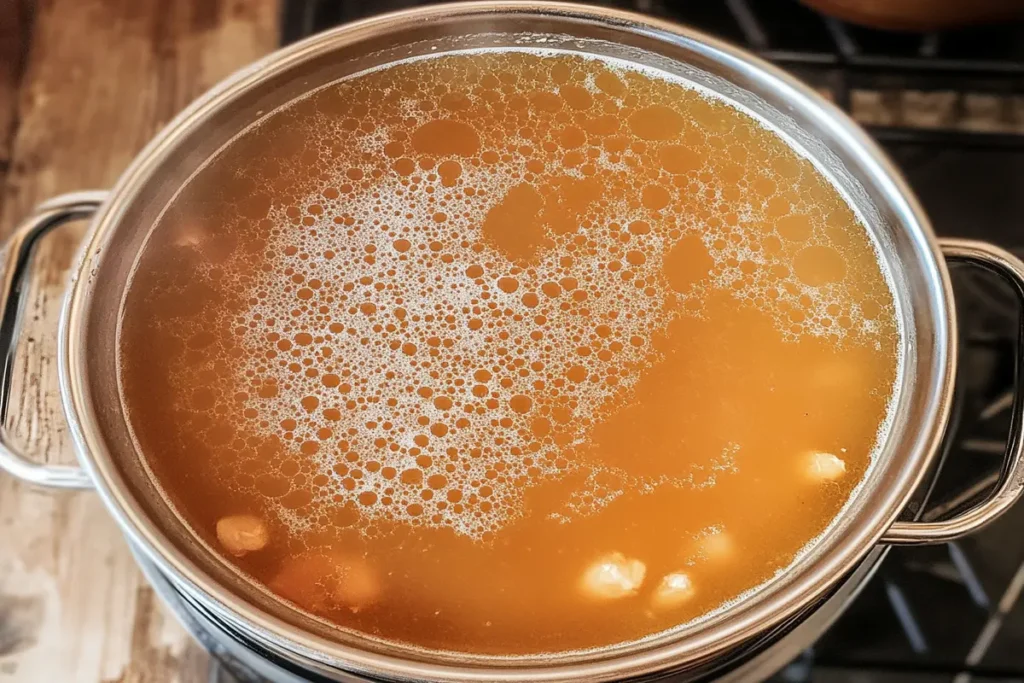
xmin=0 ymin=2 xmax=1024 ymax=682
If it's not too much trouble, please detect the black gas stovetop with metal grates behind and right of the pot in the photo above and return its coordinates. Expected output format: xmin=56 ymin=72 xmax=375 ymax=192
xmin=282 ymin=0 xmax=1024 ymax=683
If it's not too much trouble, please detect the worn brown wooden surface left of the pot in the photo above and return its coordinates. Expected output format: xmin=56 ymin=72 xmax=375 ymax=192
xmin=0 ymin=0 xmax=279 ymax=683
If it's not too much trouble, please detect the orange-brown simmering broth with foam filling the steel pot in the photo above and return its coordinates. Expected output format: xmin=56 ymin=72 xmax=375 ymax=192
xmin=120 ymin=51 xmax=899 ymax=654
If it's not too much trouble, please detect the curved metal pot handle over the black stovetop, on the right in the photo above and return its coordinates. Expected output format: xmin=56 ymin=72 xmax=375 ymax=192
xmin=882 ymin=239 xmax=1024 ymax=546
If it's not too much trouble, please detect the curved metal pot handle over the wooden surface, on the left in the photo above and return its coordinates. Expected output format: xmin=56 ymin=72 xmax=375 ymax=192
xmin=0 ymin=191 xmax=106 ymax=488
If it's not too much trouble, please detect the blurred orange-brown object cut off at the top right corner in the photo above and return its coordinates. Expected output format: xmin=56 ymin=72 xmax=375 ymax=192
xmin=801 ymin=0 xmax=1024 ymax=31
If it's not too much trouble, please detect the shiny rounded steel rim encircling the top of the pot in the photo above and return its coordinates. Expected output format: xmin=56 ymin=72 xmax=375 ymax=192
xmin=58 ymin=0 xmax=955 ymax=683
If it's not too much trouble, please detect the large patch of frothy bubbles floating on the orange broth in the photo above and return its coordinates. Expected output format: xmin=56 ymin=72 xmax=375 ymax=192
xmin=125 ymin=51 xmax=894 ymax=539
